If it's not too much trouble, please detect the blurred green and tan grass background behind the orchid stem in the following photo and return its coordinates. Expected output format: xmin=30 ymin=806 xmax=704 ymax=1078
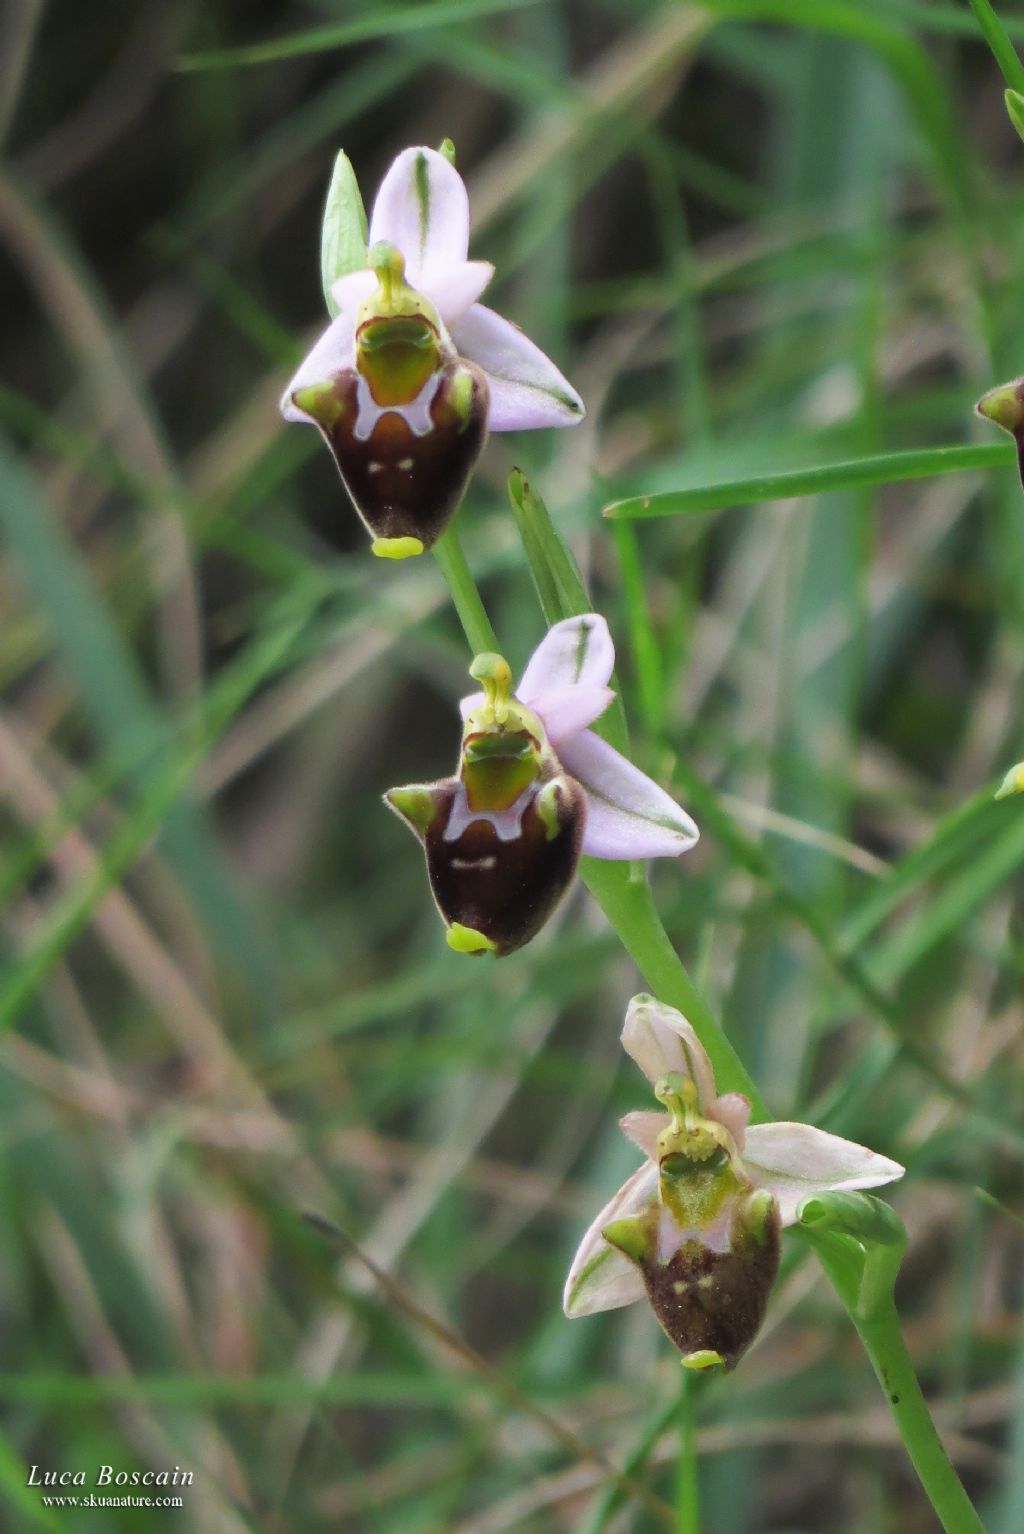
xmin=0 ymin=0 xmax=1024 ymax=1534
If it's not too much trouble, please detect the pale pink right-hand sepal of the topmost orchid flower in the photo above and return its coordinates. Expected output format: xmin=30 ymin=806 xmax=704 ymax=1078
xmin=447 ymin=302 xmax=586 ymax=431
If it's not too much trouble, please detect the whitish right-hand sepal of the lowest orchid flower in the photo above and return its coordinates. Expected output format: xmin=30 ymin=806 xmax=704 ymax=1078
xmin=743 ymin=1123 xmax=904 ymax=1226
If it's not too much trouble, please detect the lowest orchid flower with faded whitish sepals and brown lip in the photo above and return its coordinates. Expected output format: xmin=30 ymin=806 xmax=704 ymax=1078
xmin=563 ymin=996 xmax=903 ymax=1368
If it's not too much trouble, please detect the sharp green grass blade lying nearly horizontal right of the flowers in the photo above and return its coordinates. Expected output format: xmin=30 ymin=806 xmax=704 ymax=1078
xmin=604 ymin=442 xmax=1013 ymax=522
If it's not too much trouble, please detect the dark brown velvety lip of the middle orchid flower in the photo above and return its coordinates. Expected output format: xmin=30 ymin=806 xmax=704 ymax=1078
xmin=392 ymin=775 xmax=587 ymax=954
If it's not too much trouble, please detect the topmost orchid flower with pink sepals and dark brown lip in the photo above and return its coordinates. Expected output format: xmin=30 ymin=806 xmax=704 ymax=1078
xmin=281 ymin=147 xmax=584 ymax=558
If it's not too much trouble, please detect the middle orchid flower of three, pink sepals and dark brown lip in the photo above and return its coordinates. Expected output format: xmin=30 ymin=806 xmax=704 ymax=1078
xmin=385 ymin=612 xmax=697 ymax=954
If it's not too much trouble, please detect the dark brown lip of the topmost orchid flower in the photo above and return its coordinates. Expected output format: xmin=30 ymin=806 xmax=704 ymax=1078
xmin=301 ymin=357 xmax=489 ymax=549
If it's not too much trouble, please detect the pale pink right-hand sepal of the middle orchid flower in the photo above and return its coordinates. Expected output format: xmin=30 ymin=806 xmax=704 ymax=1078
xmin=558 ymin=730 xmax=701 ymax=861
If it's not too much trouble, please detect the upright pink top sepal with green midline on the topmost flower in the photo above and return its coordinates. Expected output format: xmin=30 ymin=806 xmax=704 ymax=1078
xmin=369 ymin=147 xmax=469 ymax=293
